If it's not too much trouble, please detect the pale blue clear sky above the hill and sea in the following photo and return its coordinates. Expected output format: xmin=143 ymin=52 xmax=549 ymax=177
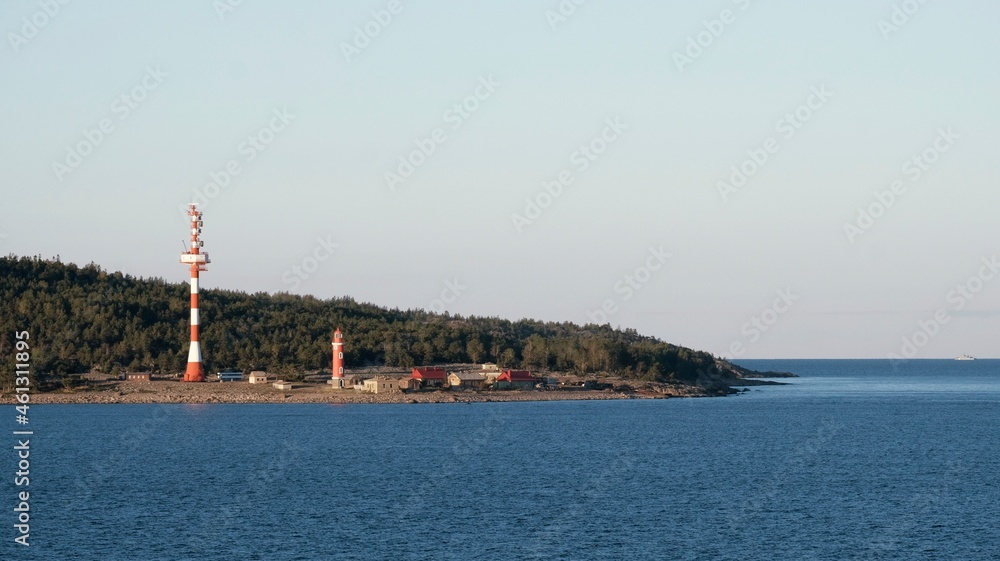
xmin=0 ymin=0 xmax=1000 ymax=358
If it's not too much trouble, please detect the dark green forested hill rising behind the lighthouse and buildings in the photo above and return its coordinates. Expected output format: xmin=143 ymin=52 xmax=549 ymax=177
xmin=0 ymin=255 xmax=752 ymax=388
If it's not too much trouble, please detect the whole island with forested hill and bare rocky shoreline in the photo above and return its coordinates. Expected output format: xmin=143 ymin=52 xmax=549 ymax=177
xmin=0 ymin=255 xmax=790 ymax=403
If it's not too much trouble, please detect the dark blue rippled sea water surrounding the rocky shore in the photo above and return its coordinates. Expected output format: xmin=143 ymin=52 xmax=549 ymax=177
xmin=0 ymin=361 xmax=1000 ymax=561
